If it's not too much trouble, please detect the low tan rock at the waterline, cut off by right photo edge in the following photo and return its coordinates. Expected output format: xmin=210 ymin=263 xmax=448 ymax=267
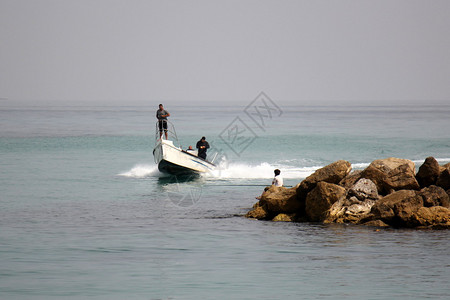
xmin=414 ymin=206 xmax=450 ymax=229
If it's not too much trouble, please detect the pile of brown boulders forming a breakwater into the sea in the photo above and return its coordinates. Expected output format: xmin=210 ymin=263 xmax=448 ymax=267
xmin=246 ymin=157 xmax=450 ymax=229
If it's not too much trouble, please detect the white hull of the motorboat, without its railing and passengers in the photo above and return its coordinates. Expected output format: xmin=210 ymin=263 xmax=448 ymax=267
xmin=153 ymin=140 xmax=215 ymax=175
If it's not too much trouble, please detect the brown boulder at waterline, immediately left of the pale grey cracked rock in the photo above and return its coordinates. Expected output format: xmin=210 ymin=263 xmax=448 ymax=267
xmin=306 ymin=180 xmax=346 ymax=222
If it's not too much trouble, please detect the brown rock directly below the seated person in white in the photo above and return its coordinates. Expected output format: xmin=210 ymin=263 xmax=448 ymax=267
xmin=259 ymin=186 xmax=301 ymax=214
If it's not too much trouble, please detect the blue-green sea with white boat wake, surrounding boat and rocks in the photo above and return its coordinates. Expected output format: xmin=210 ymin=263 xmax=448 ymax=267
xmin=0 ymin=102 xmax=450 ymax=299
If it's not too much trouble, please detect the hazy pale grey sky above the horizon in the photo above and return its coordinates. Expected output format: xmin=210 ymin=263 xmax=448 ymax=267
xmin=0 ymin=0 xmax=450 ymax=105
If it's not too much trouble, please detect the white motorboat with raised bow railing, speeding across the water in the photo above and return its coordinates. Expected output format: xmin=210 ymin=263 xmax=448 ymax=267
xmin=153 ymin=121 xmax=216 ymax=175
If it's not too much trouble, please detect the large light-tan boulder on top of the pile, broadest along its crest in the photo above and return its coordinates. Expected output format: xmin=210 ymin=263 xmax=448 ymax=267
xmin=361 ymin=157 xmax=419 ymax=194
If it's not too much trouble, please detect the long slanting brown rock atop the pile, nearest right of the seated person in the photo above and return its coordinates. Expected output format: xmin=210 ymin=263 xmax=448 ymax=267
xmin=297 ymin=160 xmax=352 ymax=201
